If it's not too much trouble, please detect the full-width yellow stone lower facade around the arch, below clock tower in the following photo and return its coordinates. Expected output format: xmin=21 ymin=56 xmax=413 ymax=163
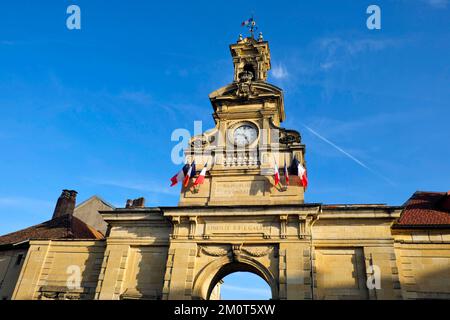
xmin=8 ymin=206 xmax=450 ymax=300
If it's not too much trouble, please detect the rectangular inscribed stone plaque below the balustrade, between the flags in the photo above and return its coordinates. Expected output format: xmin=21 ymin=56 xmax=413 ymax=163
xmin=214 ymin=181 xmax=265 ymax=198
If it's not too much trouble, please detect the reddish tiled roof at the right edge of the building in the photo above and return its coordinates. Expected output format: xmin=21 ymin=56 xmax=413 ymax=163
xmin=394 ymin=191 xmax=450 ymax=228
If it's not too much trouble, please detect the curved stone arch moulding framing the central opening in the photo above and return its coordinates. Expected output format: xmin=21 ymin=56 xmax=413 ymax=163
xmin=192 ymin=249 xmax=279 ymax=300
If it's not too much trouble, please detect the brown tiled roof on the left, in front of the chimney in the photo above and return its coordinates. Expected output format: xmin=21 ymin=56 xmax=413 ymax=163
xmin=0 ymin=214 xmax=104 ymax=246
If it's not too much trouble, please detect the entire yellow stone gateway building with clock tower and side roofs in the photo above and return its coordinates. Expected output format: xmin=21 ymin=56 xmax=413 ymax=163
xmin=0 ymin=33 xmax=450 ymax=300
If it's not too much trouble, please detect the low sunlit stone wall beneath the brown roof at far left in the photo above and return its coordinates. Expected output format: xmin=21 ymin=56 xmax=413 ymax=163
xmin=13 ymin=240 xmax=105 ymax=300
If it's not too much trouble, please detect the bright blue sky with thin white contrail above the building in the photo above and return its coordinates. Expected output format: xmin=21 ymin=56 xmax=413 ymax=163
xmin=0 ymin=0 xmax=450 ymax=298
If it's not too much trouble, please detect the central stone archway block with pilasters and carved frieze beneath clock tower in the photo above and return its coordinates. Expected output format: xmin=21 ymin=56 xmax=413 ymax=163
xmin=158 ymin=215 xmax=313 ymax=300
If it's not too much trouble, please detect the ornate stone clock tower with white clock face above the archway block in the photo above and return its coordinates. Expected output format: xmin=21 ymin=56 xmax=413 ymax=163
xmin=179 ymin=34 xmax=305 ymax=206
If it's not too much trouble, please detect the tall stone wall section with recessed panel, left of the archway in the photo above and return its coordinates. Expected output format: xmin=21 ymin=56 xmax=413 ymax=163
xmin=95 ymin=209 xmax=172 ymax=300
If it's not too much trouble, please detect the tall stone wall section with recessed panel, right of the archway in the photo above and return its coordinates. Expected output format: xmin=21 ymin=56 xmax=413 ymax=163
xmin=312 ymin=210 xmax=402 ymax=299
